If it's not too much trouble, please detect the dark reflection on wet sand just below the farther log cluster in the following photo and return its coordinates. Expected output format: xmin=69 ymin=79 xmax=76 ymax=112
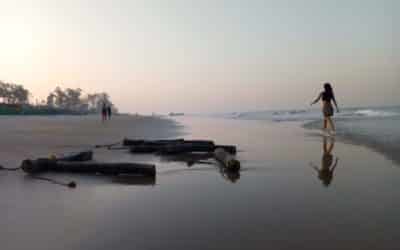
xmin=161 ymin=153 xmax=240 ymax=183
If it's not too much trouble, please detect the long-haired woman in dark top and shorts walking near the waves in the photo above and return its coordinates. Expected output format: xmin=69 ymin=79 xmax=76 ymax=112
xmin=311 ymin=83 xmax=339 ymax=134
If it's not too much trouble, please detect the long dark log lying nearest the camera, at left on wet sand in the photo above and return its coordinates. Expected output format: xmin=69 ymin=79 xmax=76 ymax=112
xmin=21 ymin=159 xmax=156 ymax=176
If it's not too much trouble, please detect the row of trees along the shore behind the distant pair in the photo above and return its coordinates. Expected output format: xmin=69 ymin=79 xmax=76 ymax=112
xmin=0 ymin=81 xmax=118 ymax=113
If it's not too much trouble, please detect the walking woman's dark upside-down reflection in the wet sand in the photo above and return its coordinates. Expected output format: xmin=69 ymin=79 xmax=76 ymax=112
xmin=310 ymin=136 xmax=339 ymax=187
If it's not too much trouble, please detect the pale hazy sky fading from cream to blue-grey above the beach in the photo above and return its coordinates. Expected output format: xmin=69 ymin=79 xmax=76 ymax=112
xmin=0 ymin=0 xmax=400 ymax=113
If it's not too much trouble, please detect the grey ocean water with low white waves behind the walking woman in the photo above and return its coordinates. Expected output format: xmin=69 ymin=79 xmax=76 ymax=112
xmin=212 ymin=106 xmax=400 ymax=164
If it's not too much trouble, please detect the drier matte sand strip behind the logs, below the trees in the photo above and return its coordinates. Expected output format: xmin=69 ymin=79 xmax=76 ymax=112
xmin=0 ymin=115 xmax=177 ymax=167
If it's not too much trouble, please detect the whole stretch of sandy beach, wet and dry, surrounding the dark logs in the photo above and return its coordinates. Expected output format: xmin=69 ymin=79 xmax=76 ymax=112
xmin=0 ymin=117 xmax=400 ymax=250
